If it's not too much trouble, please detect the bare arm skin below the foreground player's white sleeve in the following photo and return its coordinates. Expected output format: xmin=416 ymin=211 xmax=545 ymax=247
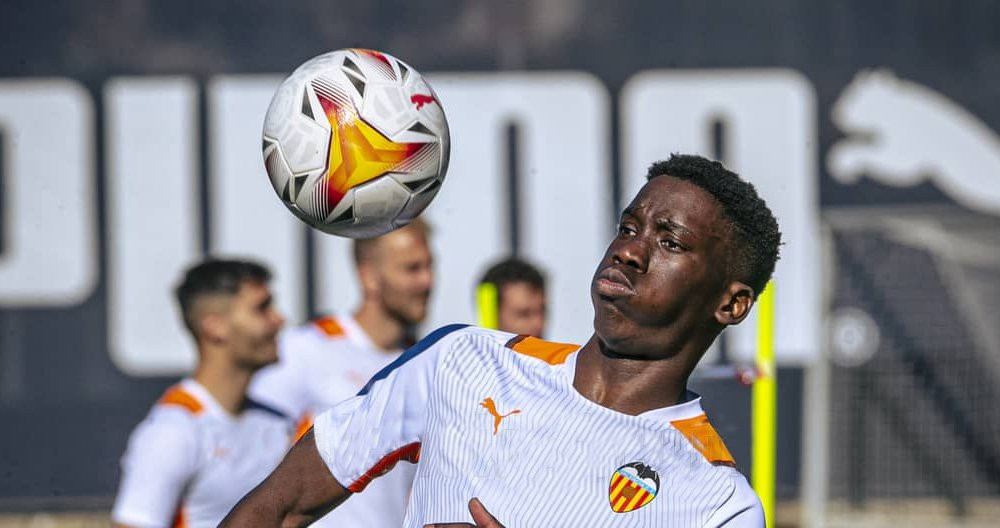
xmin=219 ymin=430 xmax=351 ymax=528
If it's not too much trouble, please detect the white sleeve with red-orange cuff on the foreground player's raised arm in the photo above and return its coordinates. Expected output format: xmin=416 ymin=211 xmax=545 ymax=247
xmin=313 ymin=325 xmax=465 ymax=493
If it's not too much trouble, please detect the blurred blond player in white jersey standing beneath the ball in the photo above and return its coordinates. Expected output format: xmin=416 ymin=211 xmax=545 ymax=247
xmin=250 ymin=219 xmax=434 ymax=528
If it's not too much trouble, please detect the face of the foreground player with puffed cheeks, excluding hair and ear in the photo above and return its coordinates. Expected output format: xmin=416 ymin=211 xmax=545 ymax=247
xmin=591 ymin=176 xmax=728 ymax=359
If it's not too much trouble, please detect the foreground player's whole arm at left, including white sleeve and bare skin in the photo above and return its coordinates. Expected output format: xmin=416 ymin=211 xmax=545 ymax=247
xmin=229 ymin=325 xmax=470 ymax=527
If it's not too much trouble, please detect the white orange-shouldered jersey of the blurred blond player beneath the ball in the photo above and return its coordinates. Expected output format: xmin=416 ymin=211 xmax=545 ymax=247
xmin=250 ymin=316 xmax=416 ymax=528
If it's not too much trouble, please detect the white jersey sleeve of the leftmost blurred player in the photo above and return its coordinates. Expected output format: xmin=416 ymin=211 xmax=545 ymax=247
xmin=111 ymin=409 xmax=198 ymax=527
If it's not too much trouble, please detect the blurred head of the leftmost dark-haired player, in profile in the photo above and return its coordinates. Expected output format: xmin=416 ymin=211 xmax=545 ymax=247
xmin=175 ymin=259 xmax=284 ymax=369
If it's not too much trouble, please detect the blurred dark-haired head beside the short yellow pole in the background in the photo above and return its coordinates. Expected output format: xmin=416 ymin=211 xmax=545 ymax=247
xmin=479 ymin=257 xmax=546 ymax=337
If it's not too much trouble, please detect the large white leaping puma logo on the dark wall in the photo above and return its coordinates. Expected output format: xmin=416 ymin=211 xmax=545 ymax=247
xmin=827 ymin=70 xmax=1000 ymax=214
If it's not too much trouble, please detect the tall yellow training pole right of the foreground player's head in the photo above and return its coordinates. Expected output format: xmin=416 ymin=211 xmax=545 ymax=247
xmin=751 ymin=282 xmax=778 ymax=527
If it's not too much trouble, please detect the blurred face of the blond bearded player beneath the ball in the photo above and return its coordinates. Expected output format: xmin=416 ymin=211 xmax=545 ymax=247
xmin=375 ymin=228 xmax=434 ymax=325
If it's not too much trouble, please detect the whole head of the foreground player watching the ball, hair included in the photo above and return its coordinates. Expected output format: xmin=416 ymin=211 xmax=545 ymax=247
xmin=591 ymin=155 xmax=781 ymax=368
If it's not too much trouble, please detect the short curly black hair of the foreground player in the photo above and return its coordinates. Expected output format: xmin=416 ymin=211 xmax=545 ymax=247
xmin=646 ymin=154 xmax=781 ymax=296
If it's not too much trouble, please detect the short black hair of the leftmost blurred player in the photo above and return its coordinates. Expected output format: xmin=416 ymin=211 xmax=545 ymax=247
xmin=174 ymin=258 xmax=271 ymax=336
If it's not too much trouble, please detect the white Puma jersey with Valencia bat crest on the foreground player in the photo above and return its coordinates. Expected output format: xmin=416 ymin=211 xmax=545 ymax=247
xmin=315 ymin=325 xmax=764 ymax=528
